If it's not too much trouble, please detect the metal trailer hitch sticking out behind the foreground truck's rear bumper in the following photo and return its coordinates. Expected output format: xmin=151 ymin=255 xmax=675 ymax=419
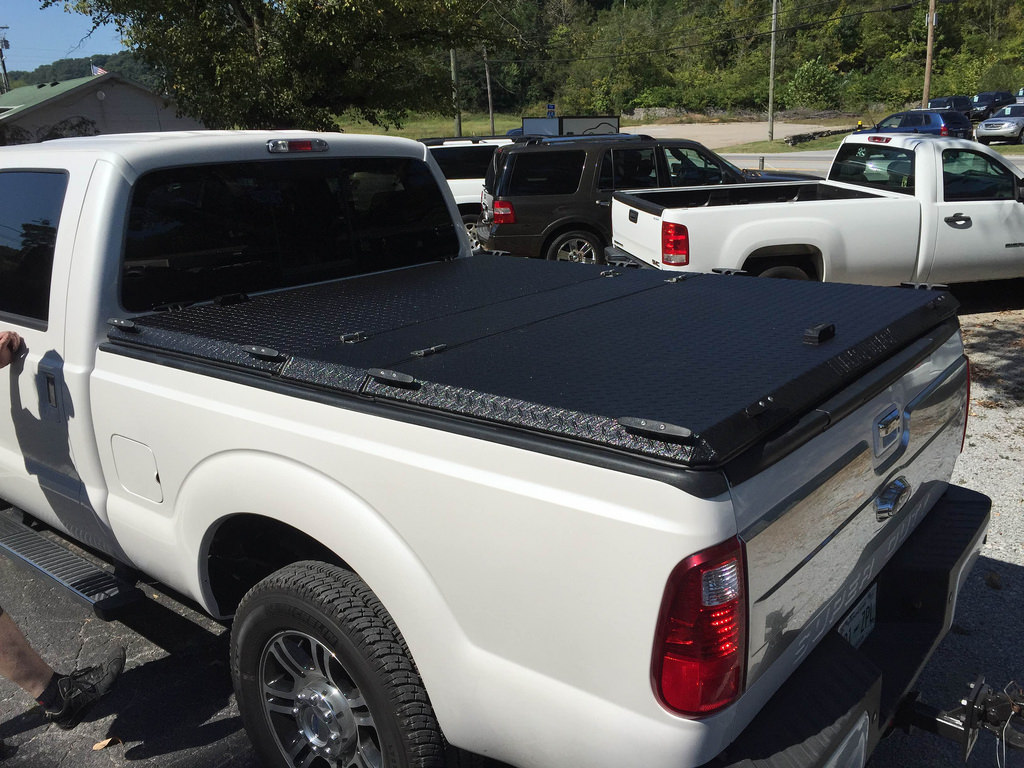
xmin=893 ymin=676 xmax=1024 ymax=765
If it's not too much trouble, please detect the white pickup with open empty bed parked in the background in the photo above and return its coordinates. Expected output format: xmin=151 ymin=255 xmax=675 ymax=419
xmin=606 ymin=133 xmax=1024 ymax=285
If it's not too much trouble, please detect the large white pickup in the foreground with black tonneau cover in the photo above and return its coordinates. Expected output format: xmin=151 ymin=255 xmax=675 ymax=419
xmin=0 ymin=132 xmax=1014 ymax=768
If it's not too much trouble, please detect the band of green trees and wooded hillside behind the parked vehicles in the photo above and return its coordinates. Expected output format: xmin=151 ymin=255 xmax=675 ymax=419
xmin=29 ymin=0 xmax=1024 ymax=128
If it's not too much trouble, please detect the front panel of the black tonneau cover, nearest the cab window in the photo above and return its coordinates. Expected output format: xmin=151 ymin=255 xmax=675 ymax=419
xmin=109 ymin=252 xmax=601 ymax=391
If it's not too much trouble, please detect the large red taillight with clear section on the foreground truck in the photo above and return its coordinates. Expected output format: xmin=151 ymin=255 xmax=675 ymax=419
xmin=652 ymin=538 xmax=746 ymax=715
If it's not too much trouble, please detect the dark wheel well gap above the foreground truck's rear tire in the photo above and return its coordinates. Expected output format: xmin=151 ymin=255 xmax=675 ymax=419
xmin=206 ymin=515 xmax=347 ymax=615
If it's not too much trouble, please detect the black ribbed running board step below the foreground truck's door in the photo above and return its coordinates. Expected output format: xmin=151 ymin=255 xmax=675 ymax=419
xmin=0 ymin=513 xmax=143 ymax=620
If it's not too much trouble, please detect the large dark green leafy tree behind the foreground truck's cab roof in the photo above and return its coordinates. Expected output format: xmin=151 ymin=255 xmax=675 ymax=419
xmin=41 ymin=0 xmax=475 ymax=129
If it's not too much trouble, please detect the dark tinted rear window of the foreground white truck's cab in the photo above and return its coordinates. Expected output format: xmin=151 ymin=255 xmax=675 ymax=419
xmin=121 ymin=158 xmax=459 ymax=311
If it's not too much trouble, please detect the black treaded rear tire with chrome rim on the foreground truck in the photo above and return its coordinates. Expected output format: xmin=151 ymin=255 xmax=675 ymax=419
xmin=231 ymin=561 xmax=444 ymax=768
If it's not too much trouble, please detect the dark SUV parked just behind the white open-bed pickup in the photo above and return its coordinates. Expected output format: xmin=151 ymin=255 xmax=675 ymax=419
xmin=476 ymin=134 xmax=818 ymax=261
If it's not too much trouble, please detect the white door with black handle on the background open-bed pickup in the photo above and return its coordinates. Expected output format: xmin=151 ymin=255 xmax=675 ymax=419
xmin=928 ymin=148 xmax=1024 ymax=283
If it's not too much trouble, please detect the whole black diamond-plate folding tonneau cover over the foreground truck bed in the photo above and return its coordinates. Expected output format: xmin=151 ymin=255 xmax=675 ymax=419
xmin=104 ymin=255 xmax=956 ymax=467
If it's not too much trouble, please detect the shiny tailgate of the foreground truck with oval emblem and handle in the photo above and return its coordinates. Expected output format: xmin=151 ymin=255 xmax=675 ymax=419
xmin=731 ymin=326 xmax=968 ymax=691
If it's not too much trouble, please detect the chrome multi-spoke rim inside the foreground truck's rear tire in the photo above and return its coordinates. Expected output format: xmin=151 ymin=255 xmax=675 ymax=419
xmin=259 ymin=631 xmax=384 ymax=768
